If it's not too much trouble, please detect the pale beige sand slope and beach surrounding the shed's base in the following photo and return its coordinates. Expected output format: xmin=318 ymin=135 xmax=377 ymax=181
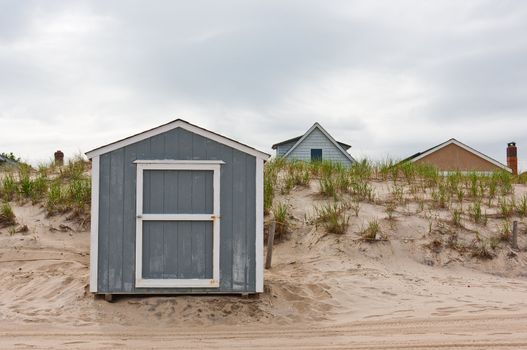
xmin=0 ymin=180 xmax=527 ymax=349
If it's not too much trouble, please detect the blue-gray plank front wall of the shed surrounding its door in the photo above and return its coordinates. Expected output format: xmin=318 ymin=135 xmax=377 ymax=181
xmin=97 ymin=128 xmax=263 ymax=294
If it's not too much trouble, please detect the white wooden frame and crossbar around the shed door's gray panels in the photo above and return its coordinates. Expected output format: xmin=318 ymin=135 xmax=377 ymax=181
xmin=134 ymin=159 xmax=225 ymax=288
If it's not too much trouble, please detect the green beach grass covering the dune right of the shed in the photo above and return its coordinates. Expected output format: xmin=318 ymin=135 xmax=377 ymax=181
xmin=264 ymin=159 xmax=527 ymax=259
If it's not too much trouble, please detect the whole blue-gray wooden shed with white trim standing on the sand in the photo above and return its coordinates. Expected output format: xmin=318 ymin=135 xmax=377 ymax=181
xmin=86 ymin=119 xmax=269 ymax=294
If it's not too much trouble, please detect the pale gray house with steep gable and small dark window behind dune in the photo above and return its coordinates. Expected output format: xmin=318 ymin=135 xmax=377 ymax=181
xmin=272 ymin=123 xmax=355 ymax=166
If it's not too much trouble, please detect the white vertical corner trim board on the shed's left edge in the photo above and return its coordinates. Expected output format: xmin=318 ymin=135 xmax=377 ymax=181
xmin=90 ymin=156 xmax=100 ymax=293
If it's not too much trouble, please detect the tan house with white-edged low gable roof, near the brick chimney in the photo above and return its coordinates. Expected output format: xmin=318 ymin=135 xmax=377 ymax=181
xmin=403 ymin=139 xmax=512 ymax=173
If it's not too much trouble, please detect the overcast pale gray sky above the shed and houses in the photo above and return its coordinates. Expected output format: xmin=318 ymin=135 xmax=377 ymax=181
xmin=0 ymin=0 xmax=527 ymax=168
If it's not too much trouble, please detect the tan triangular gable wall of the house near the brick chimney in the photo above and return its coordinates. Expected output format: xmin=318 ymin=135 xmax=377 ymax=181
xmin=416 ymin=144 xmax=502 ymax=171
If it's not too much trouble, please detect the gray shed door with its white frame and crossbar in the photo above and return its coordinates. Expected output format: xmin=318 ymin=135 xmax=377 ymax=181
xmin=135 ymin=160 xmax=223 ymax=288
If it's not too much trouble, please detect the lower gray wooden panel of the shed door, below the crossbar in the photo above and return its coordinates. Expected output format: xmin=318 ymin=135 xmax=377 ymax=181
xmin=143 ymin=221 xmax=213 ymax=279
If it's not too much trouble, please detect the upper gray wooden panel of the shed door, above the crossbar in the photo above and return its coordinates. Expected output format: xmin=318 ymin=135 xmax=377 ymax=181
xmin=143 ymin=170 xmax=213 ymax=214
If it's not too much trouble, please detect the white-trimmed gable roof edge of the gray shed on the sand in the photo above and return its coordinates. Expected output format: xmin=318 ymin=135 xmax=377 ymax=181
xmin=86 ymin=119 xmax=270 ymax=160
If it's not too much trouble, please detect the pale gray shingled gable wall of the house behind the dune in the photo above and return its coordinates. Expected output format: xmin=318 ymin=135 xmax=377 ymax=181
xmin=288 ymin=129 xmax=352 ymax=165
